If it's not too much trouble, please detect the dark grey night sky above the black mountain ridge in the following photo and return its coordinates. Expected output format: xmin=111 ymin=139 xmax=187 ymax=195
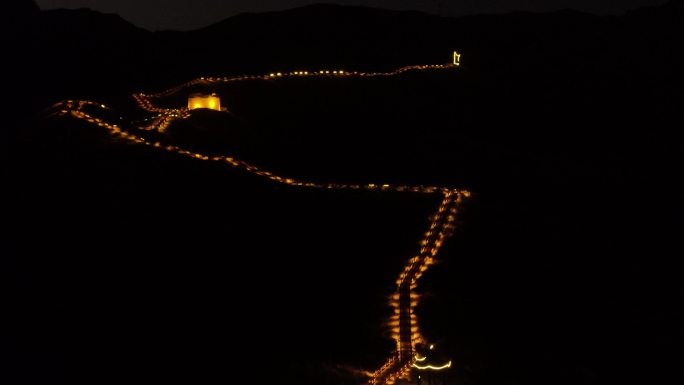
xmin=36 ymin=0 xmax=665 ymax=30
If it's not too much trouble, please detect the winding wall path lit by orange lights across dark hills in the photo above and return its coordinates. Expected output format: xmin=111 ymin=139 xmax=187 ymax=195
xmin=54 ymin=57 xmax=470 ymax=385
